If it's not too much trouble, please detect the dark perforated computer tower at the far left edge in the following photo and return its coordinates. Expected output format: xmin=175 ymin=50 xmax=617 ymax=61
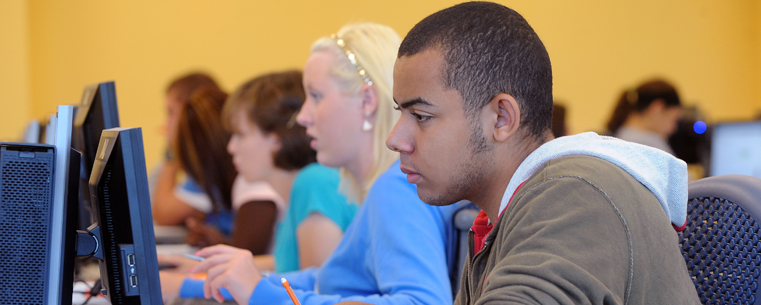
xmin=0 ymin=144 xmax=55 ymax=304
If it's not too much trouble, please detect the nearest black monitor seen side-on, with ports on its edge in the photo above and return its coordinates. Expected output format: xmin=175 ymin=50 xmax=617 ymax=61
xmin=89 ymin=128 xmax=162 ymax=304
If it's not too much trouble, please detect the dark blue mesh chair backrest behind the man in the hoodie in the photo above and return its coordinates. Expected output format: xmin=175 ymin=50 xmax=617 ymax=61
xmin=679 ymin=175 xmax=761 ymax=304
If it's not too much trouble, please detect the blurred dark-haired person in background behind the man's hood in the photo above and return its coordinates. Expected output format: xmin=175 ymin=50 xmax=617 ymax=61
xmin=607 ymin=79 xmax=682 ymax=155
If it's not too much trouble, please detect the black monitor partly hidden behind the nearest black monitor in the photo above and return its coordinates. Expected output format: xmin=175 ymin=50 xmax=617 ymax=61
xmin=72 ymin=82 xmax=119 ymax=230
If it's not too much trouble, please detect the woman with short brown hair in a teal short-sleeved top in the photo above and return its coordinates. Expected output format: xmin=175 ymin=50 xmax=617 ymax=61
xmin=161 ymin=71 xmax=358 ymax=300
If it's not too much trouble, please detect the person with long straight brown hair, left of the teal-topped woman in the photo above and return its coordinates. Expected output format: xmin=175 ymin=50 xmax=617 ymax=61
xmin=172 ymin=86 xmax=282 ymax=255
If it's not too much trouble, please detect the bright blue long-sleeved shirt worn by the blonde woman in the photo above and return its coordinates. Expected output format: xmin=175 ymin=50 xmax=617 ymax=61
xmin=249 ymin=163 xmax=454 ymax=305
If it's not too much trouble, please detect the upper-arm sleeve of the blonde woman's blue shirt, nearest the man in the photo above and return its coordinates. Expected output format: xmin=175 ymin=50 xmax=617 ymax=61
xmin=365 ymin=170 xmax=454 ymax=304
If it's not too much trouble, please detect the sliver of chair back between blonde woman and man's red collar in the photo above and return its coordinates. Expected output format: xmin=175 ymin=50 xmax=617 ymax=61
xmin=449 ymin=200 xmax=481 ymax=296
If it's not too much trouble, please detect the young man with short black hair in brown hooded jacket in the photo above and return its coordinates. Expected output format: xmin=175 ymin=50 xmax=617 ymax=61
xmin=387 ymin=2 xmax=699 ymax=304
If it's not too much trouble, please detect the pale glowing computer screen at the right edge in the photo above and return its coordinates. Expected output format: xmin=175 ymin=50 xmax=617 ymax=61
xmin=710 ymin=121 xmax=761 ymax=177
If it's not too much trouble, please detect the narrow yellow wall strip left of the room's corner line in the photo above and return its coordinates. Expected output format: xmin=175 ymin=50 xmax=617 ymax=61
xmin=0 ymin=0 xmax=31 ymax=141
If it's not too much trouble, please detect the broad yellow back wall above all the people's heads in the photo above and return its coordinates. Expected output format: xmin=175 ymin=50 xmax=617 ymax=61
xmin=0 ymin=0 xmax=761 ymax=167
